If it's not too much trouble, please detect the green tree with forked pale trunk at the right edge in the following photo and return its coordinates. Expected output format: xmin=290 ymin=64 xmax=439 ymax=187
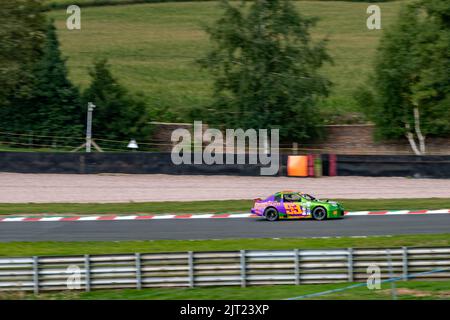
xmin=358 ymin=0 xmax=450 ymax=155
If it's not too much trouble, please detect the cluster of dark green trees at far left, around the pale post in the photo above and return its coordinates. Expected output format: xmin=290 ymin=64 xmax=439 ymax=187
xmin=0 ymin=0 xmax=148 ymax=149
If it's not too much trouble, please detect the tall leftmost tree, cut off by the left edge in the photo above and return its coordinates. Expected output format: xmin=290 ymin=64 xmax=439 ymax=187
xmin=0 ymin=0 xmax=47 ymax=131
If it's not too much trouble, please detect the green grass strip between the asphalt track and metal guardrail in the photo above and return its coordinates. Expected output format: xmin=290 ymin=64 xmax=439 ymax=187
xmin=0 ymin=233 xmax=450 ymax=256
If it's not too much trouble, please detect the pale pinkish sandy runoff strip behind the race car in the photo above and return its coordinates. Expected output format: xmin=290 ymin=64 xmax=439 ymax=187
xmin=0 ymin=173 xmax=450 ymax=203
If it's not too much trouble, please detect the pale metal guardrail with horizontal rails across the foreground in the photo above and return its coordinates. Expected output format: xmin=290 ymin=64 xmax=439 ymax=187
xmin=0 ymin=247 xmax=450 ymax=293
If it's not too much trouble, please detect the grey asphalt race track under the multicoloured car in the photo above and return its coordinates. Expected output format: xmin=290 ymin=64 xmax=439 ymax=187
xmin=0 ymin=214 xmax=450 ymax=242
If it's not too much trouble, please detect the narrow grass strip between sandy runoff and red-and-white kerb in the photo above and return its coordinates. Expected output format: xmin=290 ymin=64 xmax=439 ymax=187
xmin=0 ymin=198 xmax=450 ymax=215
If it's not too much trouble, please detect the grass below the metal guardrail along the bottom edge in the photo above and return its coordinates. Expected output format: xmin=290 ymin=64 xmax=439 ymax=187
xmin=0 ymin=281 xmax=450 ymax=300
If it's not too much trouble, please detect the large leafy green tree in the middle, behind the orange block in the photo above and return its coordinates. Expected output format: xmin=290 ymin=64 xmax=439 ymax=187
xmin=200 ymin=0 xmax=330 ymax=142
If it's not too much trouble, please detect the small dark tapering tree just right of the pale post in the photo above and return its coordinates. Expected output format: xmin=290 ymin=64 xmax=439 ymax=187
xmin=83 ymin=59 xmax=149 ymax=140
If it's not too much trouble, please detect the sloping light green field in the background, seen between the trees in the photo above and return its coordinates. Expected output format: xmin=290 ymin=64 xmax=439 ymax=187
xmin=49 ymin=1 xmax=402 ymax=121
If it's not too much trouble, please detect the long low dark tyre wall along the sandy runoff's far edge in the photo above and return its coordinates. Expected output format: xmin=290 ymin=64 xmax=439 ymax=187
xmin=0 ymin=152 xmax=450 ymax=178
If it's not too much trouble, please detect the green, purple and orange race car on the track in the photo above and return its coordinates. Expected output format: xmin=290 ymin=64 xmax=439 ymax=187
xmin=251 ymin=191 xmax=344 ymax=221
